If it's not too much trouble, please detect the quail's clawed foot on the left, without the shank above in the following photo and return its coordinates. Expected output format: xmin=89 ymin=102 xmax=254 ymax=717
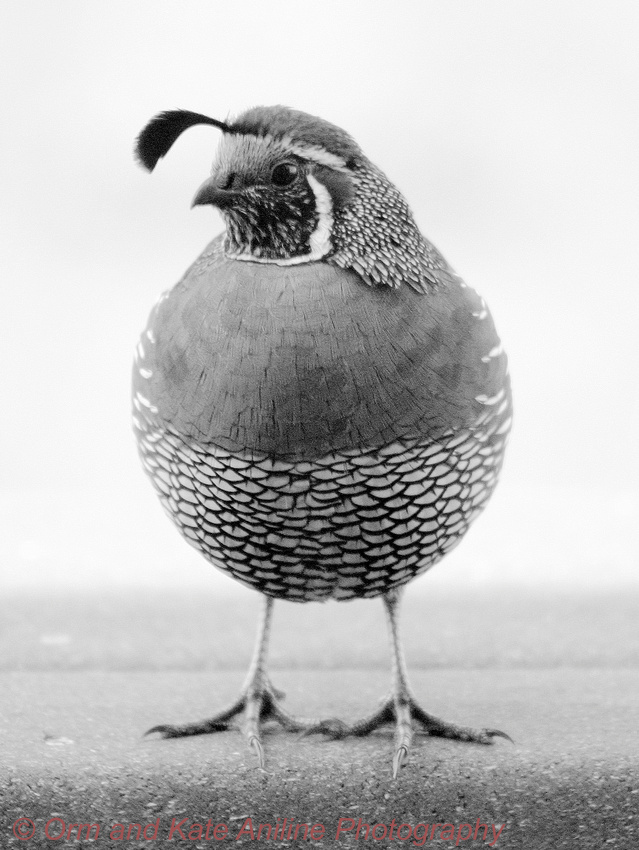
xmin=145 ymin=678 xmax=318 ymax=768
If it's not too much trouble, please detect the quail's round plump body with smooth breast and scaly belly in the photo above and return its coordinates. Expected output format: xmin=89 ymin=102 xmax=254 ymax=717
xmin=133 ymin=238 xmax=511 ymax=601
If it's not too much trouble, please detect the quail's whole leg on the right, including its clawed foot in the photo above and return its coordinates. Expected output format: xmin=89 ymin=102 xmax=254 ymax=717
xmin=305 ymin=590 xmax=512 ymax=778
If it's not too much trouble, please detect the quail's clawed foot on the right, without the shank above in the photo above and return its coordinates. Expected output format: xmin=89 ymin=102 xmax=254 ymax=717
xmin=304 ymin=694 xmax=512 ymax=779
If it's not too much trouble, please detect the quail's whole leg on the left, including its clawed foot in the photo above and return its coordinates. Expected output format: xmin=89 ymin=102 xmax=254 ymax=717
xmin=146 ymin=596 xmax=328 ymax=767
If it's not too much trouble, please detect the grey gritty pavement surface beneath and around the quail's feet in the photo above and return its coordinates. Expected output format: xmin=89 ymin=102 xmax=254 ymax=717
xmin=0 ymin=591 xmax=639 ymax=850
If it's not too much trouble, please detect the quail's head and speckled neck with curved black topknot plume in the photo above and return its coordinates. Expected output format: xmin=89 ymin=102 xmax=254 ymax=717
xmin=136 ymin=106 xmax=449 ymax=291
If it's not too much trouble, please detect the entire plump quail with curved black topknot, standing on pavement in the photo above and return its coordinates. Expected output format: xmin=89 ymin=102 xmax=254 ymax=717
xmin=133 ymin=106 xmax=511 ymax=775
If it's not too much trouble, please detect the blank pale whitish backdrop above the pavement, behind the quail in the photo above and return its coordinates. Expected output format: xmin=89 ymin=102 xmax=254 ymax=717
xmin=0 ymin=0 xmax=639 ymax=592
